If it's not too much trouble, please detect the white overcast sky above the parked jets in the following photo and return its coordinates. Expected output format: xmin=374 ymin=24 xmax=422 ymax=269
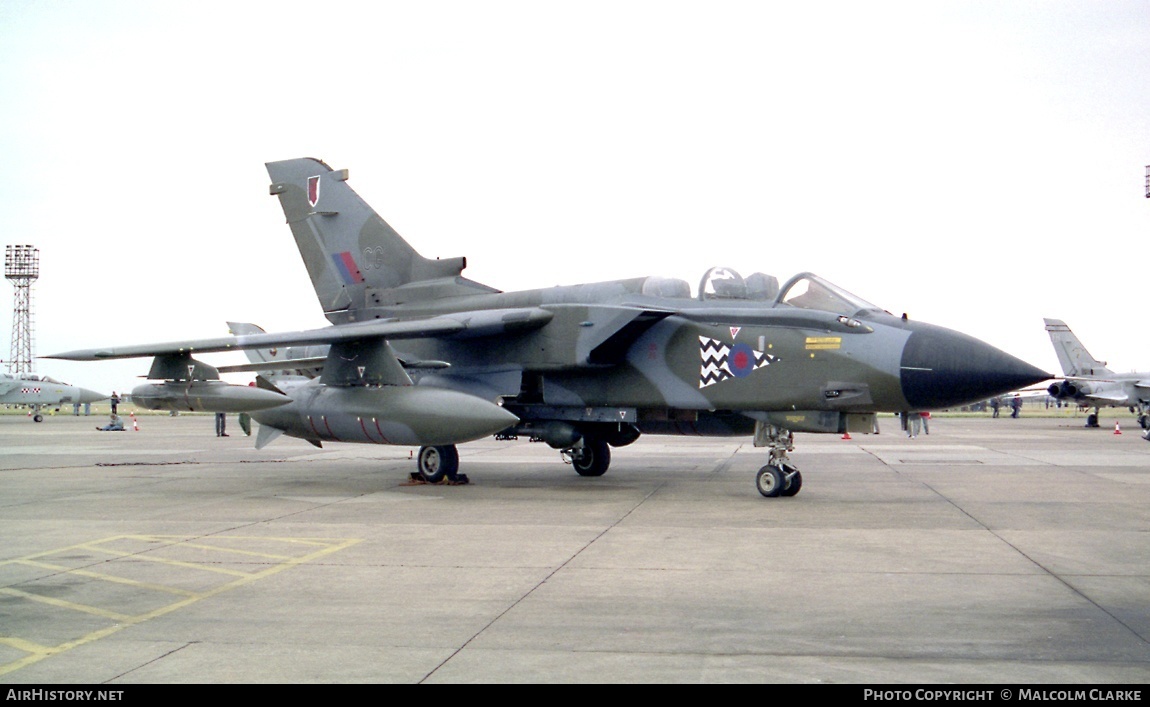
xmin=0 ymin=0 xmax=1150 ymax=392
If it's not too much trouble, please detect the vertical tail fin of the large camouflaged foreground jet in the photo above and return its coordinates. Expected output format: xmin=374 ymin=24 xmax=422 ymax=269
xmin=267 ymin=157 xmax=491 ymax=323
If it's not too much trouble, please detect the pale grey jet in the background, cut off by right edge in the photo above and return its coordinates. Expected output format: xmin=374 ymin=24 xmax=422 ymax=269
xmin=1043 ymin=320 xmax=1150 ymax=430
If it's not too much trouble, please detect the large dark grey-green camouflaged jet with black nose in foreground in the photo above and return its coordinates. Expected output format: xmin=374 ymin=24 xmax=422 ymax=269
xmin=54 ymin=159 xmax=1050 ymax=497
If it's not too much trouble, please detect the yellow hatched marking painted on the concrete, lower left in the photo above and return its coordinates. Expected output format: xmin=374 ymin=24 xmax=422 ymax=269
xmin=0 ymin=535 xmax=361 ymax=675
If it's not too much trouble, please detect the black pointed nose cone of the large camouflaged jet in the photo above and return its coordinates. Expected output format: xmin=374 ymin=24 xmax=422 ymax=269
xmin=900 ymin=322 xmax=1052 ymax=410
